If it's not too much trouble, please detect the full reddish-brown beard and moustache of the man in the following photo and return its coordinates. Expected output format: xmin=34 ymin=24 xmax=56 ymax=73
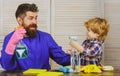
xmin=24 ymin=24 xmax=37 ymax=38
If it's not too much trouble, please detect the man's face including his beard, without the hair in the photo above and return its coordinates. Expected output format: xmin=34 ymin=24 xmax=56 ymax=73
xmin=22 ymin=11 xmax=37 ymax=38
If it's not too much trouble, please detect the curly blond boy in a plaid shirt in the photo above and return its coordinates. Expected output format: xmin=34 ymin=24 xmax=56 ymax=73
xmin=69 ymin=18 xmax=109 ymax=66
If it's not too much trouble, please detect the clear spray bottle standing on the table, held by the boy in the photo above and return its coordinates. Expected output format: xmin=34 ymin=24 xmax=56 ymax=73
xmin=69 ymin=36 xmax=80 ymax=72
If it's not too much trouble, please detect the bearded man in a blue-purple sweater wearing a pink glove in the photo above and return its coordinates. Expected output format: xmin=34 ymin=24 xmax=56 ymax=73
xmin=0 ymin=3 xmax=70 ymax=71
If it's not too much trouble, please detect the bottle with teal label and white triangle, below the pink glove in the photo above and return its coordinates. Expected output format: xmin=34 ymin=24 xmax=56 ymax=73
xmin=15 ymin=40 xmax=28 ymax=59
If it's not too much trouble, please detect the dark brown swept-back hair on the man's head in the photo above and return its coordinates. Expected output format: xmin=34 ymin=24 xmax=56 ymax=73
xmin=15 ymin=3 xmax=38 ymax=18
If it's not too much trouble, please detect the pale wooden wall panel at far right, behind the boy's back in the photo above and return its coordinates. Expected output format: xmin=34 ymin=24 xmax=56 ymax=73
xmin=104 ymin=0 xmax=120 ymax=70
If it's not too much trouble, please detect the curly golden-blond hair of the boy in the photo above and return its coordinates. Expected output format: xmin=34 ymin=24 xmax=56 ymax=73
xmin=84 ymin=17 xmax=109 ymax=42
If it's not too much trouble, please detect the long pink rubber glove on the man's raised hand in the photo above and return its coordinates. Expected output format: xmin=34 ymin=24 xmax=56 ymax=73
xmin=5 ymin=28 xmax=26 ymax=55
